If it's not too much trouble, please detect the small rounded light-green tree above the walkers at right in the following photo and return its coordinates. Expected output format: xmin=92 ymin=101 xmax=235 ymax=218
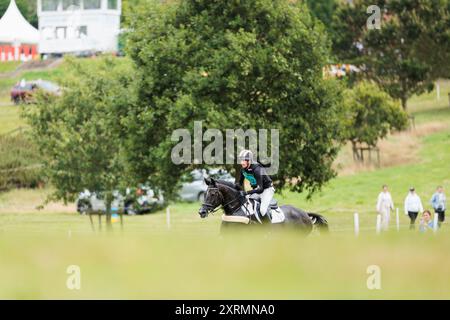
xmin=344 ymin=82 xmax=408 ymax=158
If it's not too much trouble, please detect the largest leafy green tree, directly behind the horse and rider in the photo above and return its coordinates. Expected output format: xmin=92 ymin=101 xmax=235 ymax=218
xmin=126 ymin=0 xmax=340 ymax=196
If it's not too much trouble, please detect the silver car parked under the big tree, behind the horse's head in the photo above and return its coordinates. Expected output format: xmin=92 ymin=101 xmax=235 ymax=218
xmin=178 ymin=169 xmax=235 ymax=202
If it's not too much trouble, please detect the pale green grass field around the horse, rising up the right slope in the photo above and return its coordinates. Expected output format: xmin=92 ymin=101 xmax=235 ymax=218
xmin=0 ymin=61 xmax=450 ymax=299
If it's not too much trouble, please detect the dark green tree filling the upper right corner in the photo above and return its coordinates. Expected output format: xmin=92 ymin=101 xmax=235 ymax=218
xmin=333 ymin=0 xmax=449 ymax=110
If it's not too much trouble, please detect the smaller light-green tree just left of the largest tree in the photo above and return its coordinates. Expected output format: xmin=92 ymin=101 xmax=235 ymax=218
xmin=24 ymin=58 xmax=135 ymax=225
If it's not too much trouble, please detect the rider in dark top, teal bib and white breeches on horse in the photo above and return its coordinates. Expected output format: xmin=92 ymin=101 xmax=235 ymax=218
xmin=237 ymin=150 xmax=275 ymax=220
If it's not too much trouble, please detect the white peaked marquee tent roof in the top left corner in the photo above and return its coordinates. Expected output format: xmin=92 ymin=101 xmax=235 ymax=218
xmin=0 ymin=0 xmax=39 ymax=45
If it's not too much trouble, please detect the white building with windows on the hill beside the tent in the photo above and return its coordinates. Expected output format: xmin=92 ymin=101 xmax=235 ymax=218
xmin=37 ymin=0 xmax=122 ymax=54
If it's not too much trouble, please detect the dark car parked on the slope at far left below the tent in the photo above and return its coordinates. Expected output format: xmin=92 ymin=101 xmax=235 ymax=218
xmin=10 ymin=80 xmax=61 ymax=104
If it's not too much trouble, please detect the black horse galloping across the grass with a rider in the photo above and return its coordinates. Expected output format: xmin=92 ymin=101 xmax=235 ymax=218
xmin=198 ymin=178 xmax=328 ymax=233
